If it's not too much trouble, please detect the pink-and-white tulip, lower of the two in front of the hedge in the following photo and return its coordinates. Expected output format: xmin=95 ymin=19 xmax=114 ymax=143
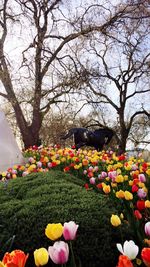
xmin=48 ymin=241 xmax=69 ymax=264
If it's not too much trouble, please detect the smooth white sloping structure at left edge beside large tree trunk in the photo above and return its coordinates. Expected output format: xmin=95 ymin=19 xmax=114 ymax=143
xmin=0 ymin=111 xmax=24 ymax=172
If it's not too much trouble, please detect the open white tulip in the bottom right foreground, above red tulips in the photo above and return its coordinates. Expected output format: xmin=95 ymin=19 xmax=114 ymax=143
xmin=116 ymin=240 xmax=139 ymax=260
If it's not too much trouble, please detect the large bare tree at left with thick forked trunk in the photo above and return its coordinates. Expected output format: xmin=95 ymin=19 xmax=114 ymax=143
xmin=0 ymin=0 xmax=134 ymax=148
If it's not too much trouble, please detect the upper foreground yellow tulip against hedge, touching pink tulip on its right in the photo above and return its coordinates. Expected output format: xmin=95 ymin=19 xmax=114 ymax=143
xmin=45 ymin=223 xmax=63 ymax=240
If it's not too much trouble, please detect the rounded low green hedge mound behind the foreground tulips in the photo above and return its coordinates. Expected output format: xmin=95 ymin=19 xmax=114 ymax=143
xmin=0 ymin=171 xmax=129 ymax=267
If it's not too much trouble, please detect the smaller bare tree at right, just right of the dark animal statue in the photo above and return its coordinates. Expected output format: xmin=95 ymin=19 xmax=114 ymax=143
xmin=69 ymin=1 xmax=150 ymax=151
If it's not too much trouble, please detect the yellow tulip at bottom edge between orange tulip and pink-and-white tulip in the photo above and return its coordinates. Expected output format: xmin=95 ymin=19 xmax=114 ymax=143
xmin=34 ymin=248 xmax=49 ymax=266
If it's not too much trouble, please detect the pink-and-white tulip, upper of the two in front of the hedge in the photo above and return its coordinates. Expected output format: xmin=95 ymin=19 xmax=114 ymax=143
xmin=63 ymin=221 xmax=79 ymax=240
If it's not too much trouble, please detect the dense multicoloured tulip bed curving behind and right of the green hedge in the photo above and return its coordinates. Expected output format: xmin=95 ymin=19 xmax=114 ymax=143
xmin=1 ymin=147 xmax=150 ymax=267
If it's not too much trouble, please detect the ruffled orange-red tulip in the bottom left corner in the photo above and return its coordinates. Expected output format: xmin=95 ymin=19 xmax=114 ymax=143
xmin=2 ymin=250 xmax=29 ymax=267
